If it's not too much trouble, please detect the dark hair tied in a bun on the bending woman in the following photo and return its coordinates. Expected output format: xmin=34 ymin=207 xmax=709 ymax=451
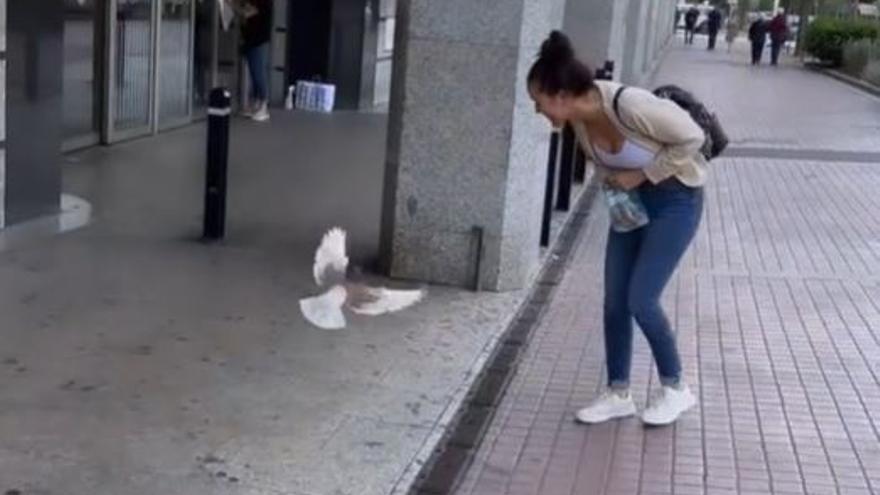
xmin=526 ymin=31 xmax=595 ymax=96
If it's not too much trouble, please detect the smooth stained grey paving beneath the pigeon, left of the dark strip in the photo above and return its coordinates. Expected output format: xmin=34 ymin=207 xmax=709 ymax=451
xmin=0 ymin=111 xmax=556 ymax=495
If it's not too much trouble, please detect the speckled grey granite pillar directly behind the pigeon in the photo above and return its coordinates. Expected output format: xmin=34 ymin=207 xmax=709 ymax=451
xmin=381 ymin=0 xmax=565 ymax=290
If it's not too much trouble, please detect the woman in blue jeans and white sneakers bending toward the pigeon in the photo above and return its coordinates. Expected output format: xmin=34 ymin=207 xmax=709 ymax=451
xmin=527 ymin=31 xmax=707 ymax=425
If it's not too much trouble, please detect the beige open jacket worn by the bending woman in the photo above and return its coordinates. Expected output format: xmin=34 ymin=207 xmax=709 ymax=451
xmin=572 ymin=81 xmax=707 ymax=187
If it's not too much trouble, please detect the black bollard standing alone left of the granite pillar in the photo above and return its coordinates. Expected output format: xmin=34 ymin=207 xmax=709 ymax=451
xmin=202 ymin=88 xmax=232 ymax=244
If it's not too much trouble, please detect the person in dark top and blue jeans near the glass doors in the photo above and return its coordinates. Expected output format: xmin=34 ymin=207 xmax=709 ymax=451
xmin=232 ymin=0 xmax=272 ymax=122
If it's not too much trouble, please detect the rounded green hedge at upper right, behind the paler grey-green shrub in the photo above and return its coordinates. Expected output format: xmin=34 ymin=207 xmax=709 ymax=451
xmin=804 ymin=17 xmax=880 ymax=67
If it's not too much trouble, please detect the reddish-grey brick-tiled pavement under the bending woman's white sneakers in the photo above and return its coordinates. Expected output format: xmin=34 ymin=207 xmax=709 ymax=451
xmin=458 ymin=37 xmax=880 ymax=495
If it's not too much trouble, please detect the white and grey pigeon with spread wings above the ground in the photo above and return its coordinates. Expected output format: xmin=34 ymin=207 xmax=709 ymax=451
xmin=299 ymin=227 xmax=425 ymax=330
